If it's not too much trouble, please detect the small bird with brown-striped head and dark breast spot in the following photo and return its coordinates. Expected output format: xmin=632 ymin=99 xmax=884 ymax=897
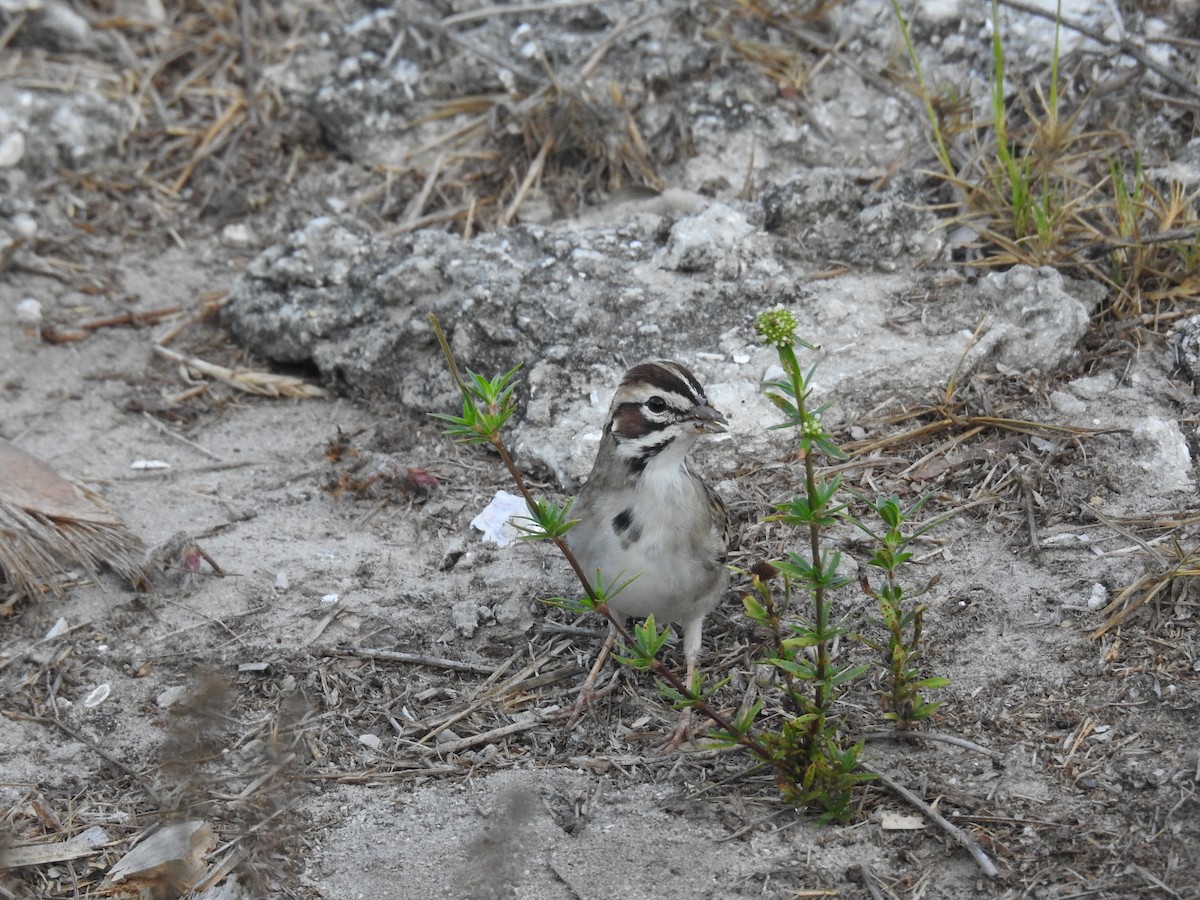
xmin=568 ymin=360 xmax=730 ymax=746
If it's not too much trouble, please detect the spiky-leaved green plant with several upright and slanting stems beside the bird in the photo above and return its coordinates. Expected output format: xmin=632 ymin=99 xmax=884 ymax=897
xmin=431 ymin=310 xmax=944 ymax=823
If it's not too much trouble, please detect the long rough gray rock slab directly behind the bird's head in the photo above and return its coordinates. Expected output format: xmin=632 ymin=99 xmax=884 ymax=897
xmin=227 ymin=217 xmax=778 ymax=418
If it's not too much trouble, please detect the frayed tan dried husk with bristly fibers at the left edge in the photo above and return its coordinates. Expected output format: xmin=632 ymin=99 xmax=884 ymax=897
xmin=0 ymin=439 xmax=146 ymax=596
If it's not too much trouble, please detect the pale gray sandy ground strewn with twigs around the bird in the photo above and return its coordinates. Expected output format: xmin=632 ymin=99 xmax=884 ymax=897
xmin=0 ymin=1 xmax=1200 ymax=900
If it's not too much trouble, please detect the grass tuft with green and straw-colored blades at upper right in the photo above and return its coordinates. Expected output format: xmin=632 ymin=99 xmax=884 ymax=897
xmin=893 ymin=0 xmax=1200 ymax=317
